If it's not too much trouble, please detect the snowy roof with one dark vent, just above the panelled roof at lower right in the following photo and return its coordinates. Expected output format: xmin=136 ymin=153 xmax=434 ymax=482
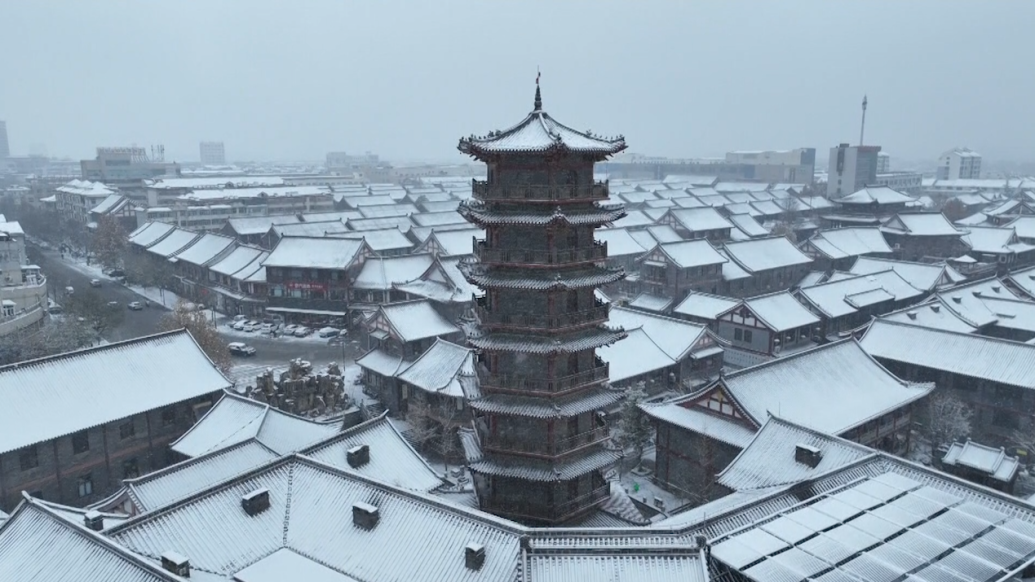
xmin=716 ymin=416 xmax=874 ymax=491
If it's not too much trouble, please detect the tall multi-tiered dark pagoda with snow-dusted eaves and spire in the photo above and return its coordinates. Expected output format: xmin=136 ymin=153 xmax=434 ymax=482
xmin=457 ymin=82 xmax=625 ymax=524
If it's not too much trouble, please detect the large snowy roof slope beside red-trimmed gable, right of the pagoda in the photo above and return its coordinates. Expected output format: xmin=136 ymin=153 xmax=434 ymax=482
xmin=721 ymin=339 xmax=934 ymax=435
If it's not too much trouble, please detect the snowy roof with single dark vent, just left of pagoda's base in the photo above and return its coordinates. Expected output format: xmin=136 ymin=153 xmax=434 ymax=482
xmin=301 ymin=412 xmax=443 ymax=491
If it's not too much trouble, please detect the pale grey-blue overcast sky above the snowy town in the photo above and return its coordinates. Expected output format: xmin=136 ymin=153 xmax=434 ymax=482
xmin=0 ymin=0 xmax=1035 ymax=162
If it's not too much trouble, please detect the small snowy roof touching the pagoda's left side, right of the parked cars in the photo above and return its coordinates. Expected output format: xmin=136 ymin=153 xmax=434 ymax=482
xmin=396 ymin=338 xmax=477 ymax=398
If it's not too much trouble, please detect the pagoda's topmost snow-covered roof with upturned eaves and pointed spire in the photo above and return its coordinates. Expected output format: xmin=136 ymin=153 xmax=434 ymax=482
xmin=456 ymin=85 xmax=626 ymax=158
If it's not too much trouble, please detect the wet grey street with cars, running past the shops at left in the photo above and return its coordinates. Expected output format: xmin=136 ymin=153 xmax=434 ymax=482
xmin=26 ymin=241 xmax=362 ymax=368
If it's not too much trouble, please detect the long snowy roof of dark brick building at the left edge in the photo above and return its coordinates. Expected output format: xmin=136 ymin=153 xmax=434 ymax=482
xmin=0 ymin=330 xmax=230 ymax=453
